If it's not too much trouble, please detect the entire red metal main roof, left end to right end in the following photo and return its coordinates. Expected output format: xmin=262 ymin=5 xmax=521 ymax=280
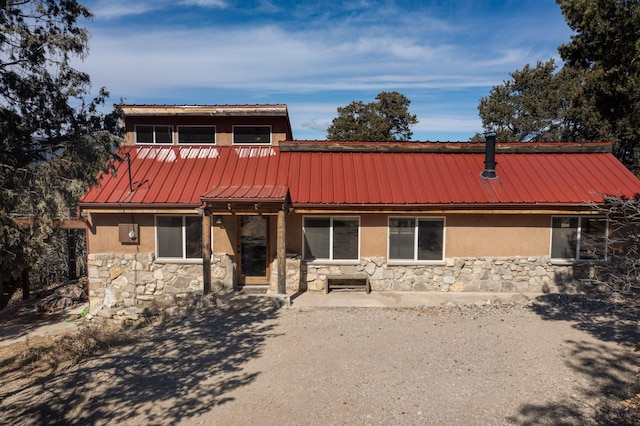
xmin=81 ymin=146 xmax=640 ymax=207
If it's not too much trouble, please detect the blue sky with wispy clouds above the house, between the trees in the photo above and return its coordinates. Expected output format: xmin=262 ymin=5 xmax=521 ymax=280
xmin=76 ymin=0 xmax=571 ymax=141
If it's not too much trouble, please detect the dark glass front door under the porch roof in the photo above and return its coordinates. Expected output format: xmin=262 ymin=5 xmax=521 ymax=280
xmin=240 ymin=216 xmax=269 ymax=284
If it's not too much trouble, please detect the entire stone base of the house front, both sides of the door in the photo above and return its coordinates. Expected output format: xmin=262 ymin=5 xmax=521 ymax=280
xmin=88 ymin=253 xmax=596 ymax=315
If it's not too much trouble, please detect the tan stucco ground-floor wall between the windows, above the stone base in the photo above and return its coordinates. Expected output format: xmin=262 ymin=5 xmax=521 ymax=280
xmin=88 ymin=214 xmax=551 ymax=259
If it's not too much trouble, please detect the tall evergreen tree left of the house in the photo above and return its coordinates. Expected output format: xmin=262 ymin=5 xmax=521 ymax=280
xmin=0 ymin=0 xmax=119 ymax=281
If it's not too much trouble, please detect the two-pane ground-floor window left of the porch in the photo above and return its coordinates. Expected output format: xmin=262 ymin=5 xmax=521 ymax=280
xmin=156 ymin=216 xmax=202 ymax=259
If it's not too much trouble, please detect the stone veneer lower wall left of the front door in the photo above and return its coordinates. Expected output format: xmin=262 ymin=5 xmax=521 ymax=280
xmin=87 ymin=253 xmax=233 ymax=310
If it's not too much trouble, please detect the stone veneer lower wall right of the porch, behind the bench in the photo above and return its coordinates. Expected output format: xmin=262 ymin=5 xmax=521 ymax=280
xmin=303 ymin=256 xmax=595 ymax=293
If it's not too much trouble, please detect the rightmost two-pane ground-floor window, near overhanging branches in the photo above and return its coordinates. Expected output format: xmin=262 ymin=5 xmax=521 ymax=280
xmin=551 ymin=216 xmax=607 ymax=260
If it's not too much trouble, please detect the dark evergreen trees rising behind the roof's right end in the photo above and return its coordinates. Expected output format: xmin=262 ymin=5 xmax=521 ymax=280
xmin=474 ymin=0 xmax=640 ymax=173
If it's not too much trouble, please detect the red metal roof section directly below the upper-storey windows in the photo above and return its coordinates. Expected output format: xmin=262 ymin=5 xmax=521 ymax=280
xmin=81 ymin=146 xmax=287 ymax=207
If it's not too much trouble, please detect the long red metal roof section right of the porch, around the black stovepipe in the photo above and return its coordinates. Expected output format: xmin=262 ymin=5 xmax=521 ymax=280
xmin=288 ymin=152 xmax=640 ymax=206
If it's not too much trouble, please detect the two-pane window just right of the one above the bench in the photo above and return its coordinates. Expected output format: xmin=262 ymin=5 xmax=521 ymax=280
xmin=389 ymin=217 xmax=444 ymax=261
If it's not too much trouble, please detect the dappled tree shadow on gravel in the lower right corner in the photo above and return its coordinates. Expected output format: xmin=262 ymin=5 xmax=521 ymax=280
xmin=509 ymin=294 xmax=640 ymax=425
